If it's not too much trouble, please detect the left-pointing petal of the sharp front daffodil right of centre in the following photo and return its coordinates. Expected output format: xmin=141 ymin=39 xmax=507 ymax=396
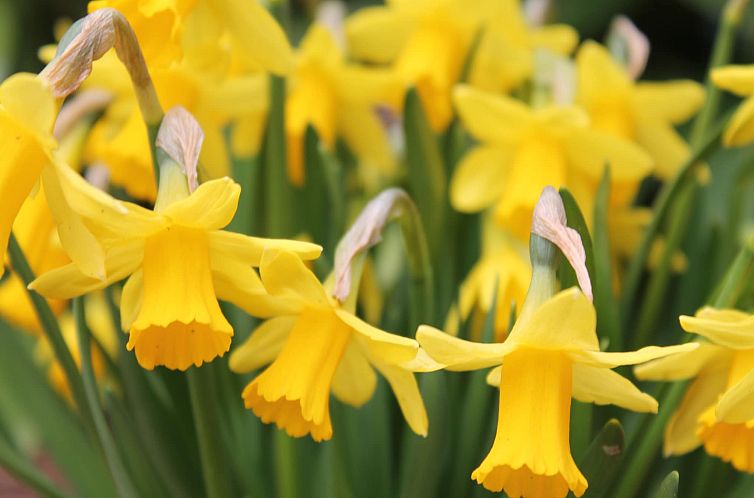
xmin=416 ymin=325 xmax=513 ymax=371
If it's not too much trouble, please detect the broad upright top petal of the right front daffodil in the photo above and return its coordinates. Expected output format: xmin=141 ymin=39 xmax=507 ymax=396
xmin=506 ymin=287 xmax=599 ymax=351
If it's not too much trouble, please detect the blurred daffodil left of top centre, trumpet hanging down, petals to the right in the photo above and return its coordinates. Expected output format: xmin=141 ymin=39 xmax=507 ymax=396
xmin=285 ymin=24 xmax=402 ymax=186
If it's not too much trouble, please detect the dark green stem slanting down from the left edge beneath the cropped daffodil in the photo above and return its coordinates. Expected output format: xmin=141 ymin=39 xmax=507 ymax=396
xmin=8 ymin=232 xmax=93 ymax=431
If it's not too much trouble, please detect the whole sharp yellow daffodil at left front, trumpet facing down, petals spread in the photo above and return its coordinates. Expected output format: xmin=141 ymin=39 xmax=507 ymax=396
xmin=31 ymin=164 xmax=321 ymax=370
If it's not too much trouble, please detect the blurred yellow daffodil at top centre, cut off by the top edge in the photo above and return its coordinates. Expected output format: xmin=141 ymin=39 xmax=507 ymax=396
xmin=346 ymin=0 xmax=486 ymax=132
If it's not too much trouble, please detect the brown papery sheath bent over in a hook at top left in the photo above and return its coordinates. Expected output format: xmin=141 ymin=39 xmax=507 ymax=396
xmin=40 ymin=8 xmax=162 ymax=124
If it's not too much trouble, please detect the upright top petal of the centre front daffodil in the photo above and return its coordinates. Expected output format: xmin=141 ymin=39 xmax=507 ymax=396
xmin=259 ymin=250 xmax=329 ymax=307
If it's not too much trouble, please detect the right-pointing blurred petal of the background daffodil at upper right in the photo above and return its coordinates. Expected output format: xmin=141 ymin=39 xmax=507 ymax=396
xmin=634 ymin=80 xmax=704 ymax=124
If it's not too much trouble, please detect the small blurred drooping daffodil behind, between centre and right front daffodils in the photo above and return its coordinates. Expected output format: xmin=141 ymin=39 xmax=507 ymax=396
xmin=458 ymin=218 xmax=531 ymax=341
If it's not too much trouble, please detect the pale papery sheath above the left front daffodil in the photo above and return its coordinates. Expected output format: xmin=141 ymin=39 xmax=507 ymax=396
xmin=155 ymin=106 xmax=204 ymax=212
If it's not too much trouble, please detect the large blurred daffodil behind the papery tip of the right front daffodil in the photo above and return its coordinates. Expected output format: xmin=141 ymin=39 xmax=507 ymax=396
xmin=450 ymin=85 xmax=652 ymax=236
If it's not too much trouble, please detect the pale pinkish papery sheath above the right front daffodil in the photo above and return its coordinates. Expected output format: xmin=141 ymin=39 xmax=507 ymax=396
xmin=531 ymin=186 xmax=592 ymax=300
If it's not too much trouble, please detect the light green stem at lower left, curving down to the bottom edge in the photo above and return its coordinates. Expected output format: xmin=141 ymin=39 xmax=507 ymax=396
xmin=73 ymin=297 xmax=139 ymax=498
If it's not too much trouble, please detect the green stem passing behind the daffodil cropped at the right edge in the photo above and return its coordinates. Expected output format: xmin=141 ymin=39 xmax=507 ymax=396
xmin=613 ymin=236 xmax=754 ymax=498
